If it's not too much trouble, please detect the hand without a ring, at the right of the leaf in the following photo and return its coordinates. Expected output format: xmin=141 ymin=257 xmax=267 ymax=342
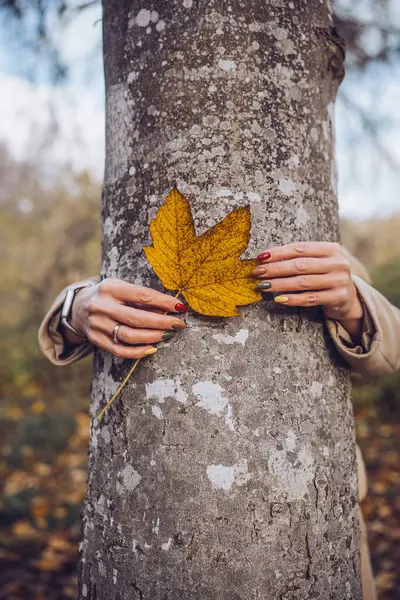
xmin=252 ymin=242 xmax=363 ymax=323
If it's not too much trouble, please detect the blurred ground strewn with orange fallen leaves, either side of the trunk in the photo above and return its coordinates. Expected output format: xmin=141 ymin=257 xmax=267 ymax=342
xmin=0 ymin=409 xmax=400 ymax=600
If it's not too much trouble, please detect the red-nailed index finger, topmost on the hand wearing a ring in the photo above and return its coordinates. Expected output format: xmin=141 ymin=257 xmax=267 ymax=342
xmin=102 ymin=279 xmax=187 ymax=313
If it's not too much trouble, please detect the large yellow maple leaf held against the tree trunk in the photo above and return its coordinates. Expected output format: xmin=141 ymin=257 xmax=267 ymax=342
xmin=144 ymin=188 xmax=261 ymax=317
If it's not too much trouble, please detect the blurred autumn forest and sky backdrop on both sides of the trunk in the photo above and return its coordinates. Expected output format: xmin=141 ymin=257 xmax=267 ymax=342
xmin=0 ymin=0 xmax=400 ymax=600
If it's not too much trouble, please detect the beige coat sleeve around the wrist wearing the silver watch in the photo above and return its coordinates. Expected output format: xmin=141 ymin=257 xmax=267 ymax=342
xmin=38 ymin=277 xmax=100 ymax=365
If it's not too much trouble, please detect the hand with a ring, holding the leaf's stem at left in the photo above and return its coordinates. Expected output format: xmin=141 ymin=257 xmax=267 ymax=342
xmin=65 ymin=278 xmax=187 ymax=358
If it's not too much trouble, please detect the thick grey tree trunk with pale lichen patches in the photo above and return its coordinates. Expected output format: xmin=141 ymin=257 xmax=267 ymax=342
xmin=80 ymin=0 xmax=361 ymax=600
